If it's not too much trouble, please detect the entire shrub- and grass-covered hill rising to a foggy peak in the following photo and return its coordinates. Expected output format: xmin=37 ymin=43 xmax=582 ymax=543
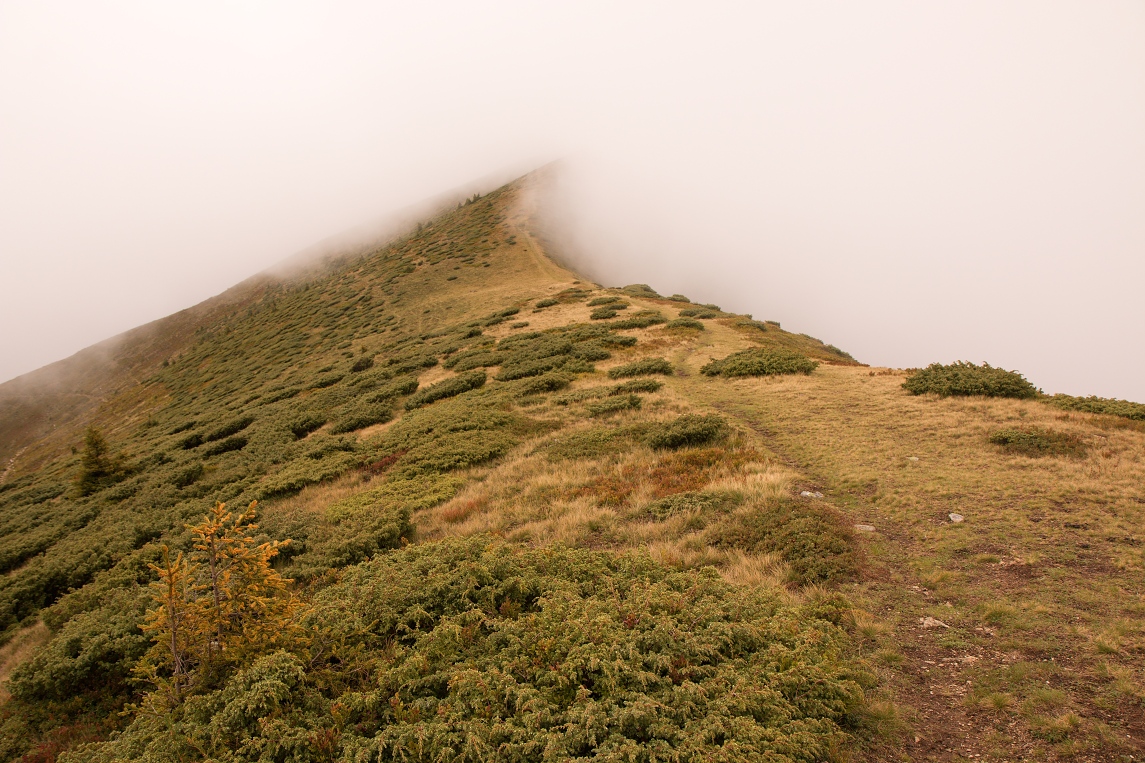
xmin=0 ymin=178 xmax=1145 ymax=762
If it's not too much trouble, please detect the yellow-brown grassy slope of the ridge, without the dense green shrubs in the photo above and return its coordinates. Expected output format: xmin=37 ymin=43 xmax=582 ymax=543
xmin=0 ymin=174 xmax=1145 ymax=760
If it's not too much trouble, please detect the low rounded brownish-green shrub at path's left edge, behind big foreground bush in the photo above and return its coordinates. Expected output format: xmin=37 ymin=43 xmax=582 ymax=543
xmin=710 ymin=500 xmax=859 ymax=585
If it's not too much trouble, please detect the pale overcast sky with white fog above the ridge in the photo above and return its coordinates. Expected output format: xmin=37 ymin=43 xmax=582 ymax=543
xmin=0 ymin=0 xmax=1145 ymax=401
